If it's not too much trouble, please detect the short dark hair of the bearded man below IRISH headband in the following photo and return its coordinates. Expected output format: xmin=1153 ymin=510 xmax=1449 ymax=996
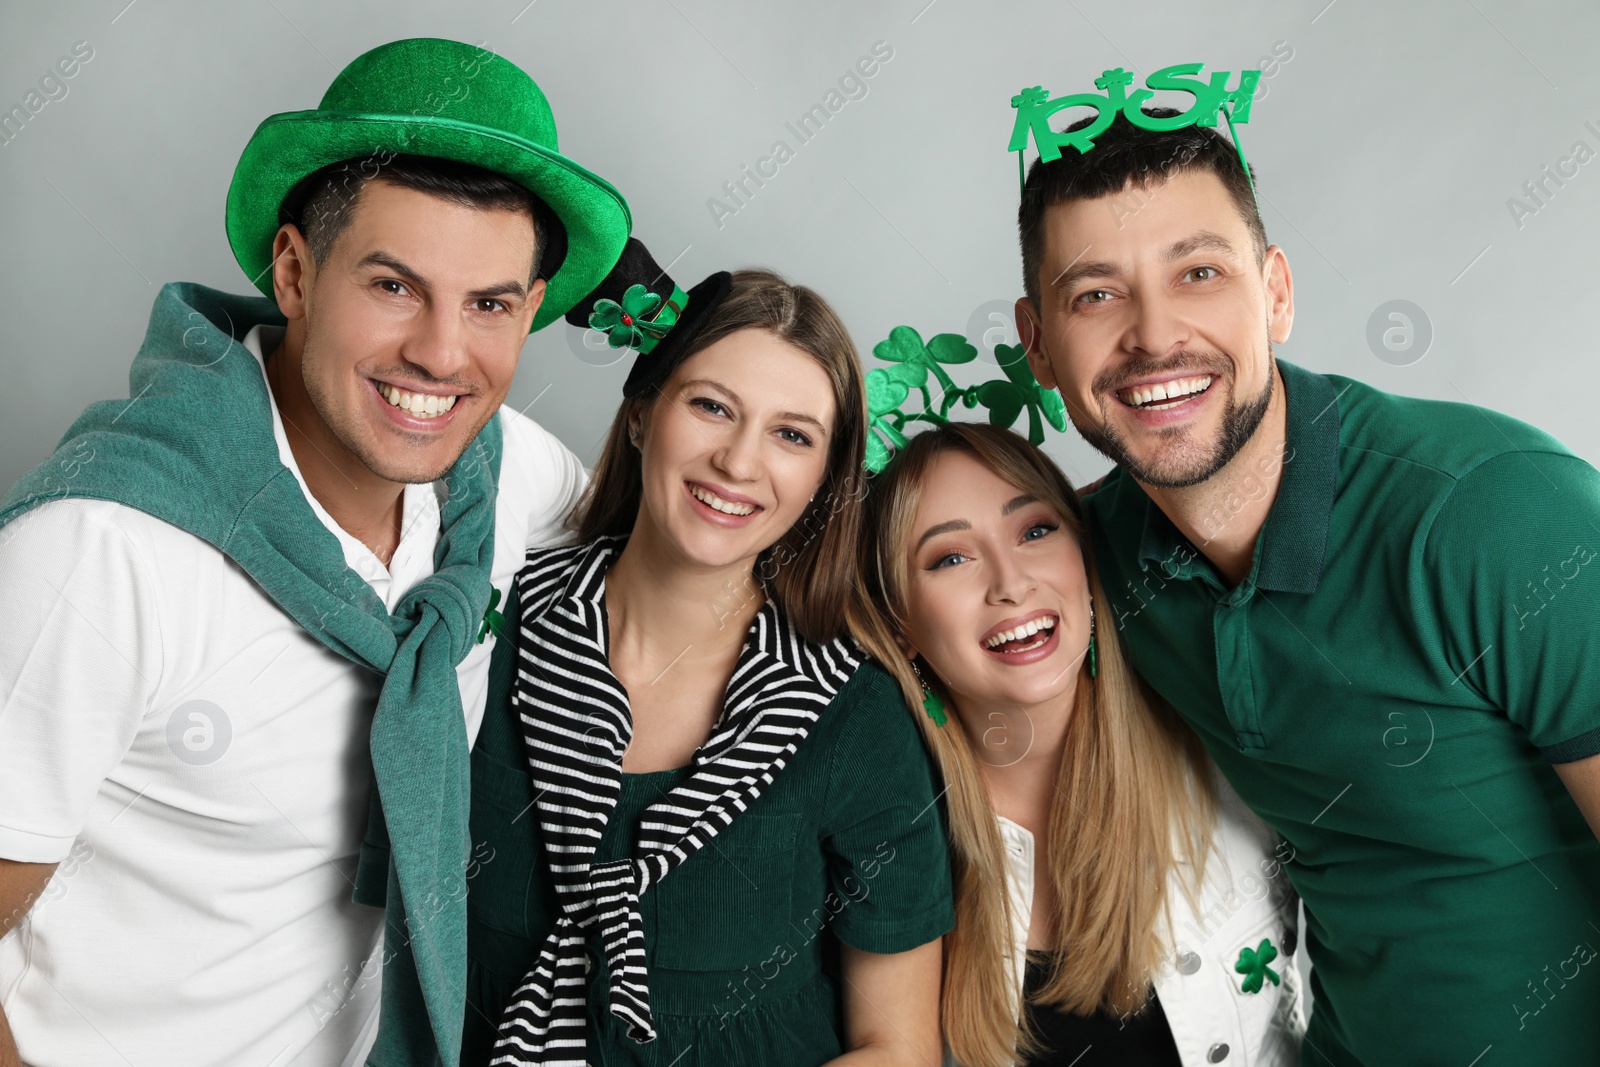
xmin=1016 ymin=107 xmax=1267 ymax=310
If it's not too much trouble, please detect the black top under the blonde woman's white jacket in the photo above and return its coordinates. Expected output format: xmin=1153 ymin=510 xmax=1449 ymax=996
xmin=1022 ymin=952 xmax=1182 ymax=1067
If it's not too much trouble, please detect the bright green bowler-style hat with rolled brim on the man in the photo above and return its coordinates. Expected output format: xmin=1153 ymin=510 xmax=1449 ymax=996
xmin=227 ymin=37 xmax=632 ymax=330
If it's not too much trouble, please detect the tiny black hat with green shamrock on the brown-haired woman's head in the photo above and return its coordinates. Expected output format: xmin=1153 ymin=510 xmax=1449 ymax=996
xmin=566 ymin=237 xmax=733 ymax=397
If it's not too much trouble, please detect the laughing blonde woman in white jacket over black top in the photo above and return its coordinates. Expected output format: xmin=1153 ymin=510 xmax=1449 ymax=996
xmin=859 ymin=422 xmax=1304 ymax=1067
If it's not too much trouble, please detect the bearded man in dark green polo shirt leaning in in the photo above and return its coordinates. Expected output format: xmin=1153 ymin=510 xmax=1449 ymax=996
xmin=1016 ymin=112 xmax=1600 ymax=1067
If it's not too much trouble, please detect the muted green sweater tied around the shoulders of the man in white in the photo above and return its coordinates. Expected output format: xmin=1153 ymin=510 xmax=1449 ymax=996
xmin=0 ymin=283 xmax=501 ymax=1067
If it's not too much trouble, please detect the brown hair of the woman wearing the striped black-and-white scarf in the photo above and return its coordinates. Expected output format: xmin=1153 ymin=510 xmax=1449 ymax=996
xmin=571 ymin=270 xmax=867 ymax=641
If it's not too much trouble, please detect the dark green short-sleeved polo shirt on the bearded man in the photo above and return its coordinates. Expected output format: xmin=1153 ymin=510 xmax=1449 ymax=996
xmin=1085 ymin=360 xmax=1600 ymax=1067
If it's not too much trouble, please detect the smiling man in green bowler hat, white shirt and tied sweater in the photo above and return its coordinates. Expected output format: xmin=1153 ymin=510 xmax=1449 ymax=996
xmin=0 ymin=38 xmax=630 ymax=1067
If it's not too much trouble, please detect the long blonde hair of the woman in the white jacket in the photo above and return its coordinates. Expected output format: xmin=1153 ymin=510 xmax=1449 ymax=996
xmin=853 ymin=422 xmax=1214 ymax=1067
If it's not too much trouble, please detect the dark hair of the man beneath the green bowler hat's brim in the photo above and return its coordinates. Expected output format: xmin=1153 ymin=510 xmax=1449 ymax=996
xmin=278 ymin=152 xmax=566 ymax=285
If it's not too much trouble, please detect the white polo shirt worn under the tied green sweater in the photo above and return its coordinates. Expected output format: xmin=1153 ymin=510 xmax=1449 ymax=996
xmin=0 ymin=326 xmax=587 ymax=1067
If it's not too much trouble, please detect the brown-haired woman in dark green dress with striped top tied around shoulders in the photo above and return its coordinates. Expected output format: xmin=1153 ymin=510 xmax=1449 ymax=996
xmin=462 ymin=242 xmax=954 ymax=1067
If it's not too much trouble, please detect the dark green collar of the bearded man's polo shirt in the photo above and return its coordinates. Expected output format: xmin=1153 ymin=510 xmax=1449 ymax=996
xmin=1139 ymin=358 xmax=1339 ymax=593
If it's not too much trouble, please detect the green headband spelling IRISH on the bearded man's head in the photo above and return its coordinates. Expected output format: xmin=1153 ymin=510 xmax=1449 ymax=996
xmin=1006 ymin=62 xmax=1261 ymax=197
